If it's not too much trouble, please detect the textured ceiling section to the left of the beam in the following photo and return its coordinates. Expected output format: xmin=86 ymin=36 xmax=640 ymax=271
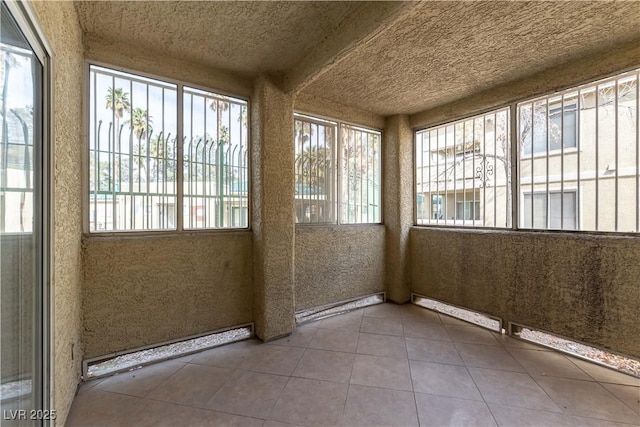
xmin=76 ymin=1 xmax=358 ymax=77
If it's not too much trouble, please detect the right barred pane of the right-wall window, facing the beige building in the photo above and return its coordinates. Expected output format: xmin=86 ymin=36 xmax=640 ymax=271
xmin=516 ymin=70 xmax=640 ymax=232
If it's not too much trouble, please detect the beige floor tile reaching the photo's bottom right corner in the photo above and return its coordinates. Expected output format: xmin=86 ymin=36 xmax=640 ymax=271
xmin=536 ymin=377 xmax=640 ymax=423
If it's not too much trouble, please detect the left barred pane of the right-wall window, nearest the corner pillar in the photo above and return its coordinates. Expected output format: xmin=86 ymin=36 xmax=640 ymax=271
xmin=415 ymin=108 xmax=512 ymax=228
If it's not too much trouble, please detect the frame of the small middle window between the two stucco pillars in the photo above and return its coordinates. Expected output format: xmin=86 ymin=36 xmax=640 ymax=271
xmin=293 ymin=110 xmax=384 ymax=227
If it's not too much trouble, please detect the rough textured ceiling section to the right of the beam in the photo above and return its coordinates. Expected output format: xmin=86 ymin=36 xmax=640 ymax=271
xmin=305 ymin=1 xmax=640 ymax=115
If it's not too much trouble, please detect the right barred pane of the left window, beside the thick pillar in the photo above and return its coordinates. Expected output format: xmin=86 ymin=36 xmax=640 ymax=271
xmin=183 ymin=87 xmax=249 ymax=229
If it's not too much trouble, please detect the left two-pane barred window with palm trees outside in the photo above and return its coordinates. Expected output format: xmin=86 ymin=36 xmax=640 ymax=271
xmin=89 ymin=65 xmax=249 ymax=232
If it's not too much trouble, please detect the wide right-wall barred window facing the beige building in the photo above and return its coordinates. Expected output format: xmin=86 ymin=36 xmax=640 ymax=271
xmin=415 ymin=70 xmax=640 ymax=233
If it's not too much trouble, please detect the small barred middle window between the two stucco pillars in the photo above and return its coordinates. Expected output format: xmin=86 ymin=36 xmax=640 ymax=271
xmin=294 ymin=114 xmax=382 ymax=224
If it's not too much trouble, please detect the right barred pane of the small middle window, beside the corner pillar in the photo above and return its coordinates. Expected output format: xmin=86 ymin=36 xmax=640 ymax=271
xmin=340 ymin=124 xmax=382 ymax=224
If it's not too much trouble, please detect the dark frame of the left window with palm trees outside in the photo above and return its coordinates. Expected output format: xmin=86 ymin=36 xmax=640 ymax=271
xmin=82 ymin=59 xmax=253 ymax=237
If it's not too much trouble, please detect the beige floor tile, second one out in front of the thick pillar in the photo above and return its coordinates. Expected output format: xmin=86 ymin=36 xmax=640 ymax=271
xmin=206 ymin=371 xmax=288 ymax=419
